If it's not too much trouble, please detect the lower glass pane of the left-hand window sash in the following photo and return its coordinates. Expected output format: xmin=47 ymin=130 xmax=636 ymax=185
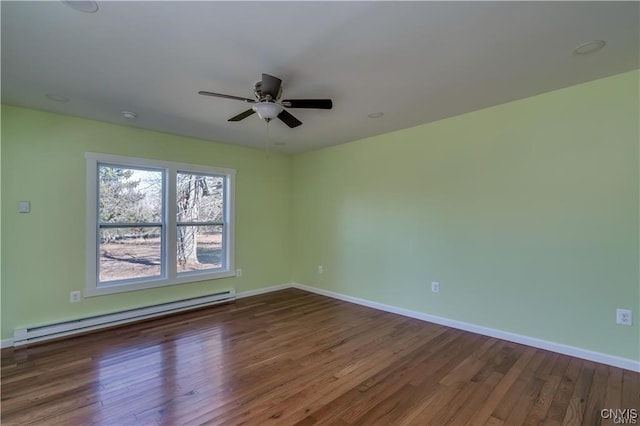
xmin=99 ymin=226 xmax=162 ymax=282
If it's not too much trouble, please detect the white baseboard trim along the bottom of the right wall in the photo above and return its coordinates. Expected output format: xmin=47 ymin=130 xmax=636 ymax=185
xmin=291 ymin=283 xmax=640 ymax=372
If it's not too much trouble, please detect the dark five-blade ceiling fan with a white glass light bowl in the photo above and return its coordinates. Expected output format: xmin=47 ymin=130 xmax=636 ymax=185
xmin=198 ymin=74 xmax=333 ymax=128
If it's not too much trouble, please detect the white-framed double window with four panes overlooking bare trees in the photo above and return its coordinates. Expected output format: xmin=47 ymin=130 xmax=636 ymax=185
xmin=85 ymin=153 xmax=235 ymax=296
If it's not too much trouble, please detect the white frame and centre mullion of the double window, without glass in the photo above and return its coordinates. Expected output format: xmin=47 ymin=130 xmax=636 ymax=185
xmin=84 ymin=152 xmax=236 ymax=297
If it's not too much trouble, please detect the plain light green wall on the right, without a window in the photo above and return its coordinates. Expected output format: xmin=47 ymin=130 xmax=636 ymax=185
xmin=292 ymin=71 xmax=640 ymax=360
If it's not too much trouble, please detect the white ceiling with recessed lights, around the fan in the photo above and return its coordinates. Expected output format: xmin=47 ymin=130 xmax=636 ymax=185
xmin=1 ymin=1 xmax=640 ymax=153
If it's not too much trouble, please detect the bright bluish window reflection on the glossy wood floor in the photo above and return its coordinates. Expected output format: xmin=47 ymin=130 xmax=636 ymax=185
xmin=94 ymin=325 xmax=229 ymax=423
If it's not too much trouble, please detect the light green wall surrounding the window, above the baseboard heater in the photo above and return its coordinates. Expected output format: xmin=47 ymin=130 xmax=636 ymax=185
xmin=1 ymin=106 xmax=292 ymax=339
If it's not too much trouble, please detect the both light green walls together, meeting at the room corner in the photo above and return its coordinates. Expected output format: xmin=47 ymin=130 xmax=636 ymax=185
xmin=0 ymin=71 xmax=640 ymax=360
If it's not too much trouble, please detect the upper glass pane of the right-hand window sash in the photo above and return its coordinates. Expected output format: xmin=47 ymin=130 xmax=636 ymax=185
xmin=176 ymin=172 xmax=224 ymax=222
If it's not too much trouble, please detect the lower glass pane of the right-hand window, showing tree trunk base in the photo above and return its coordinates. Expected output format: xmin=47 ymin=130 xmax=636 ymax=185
xmin=177 ymin=225 xmax=224 ymax=272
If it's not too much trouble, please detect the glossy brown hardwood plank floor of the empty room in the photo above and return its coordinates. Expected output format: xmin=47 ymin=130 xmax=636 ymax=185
xmin=1 ymin=289 xmax=640 ymax=425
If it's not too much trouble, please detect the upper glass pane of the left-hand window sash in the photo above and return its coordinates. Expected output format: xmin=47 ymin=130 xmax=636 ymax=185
xmin=98 ymin=164 xmax=163 ymax=223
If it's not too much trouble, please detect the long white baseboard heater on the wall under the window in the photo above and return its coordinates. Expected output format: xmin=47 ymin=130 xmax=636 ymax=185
xmin=13 ymin=289 xmax=236 ymax=346
